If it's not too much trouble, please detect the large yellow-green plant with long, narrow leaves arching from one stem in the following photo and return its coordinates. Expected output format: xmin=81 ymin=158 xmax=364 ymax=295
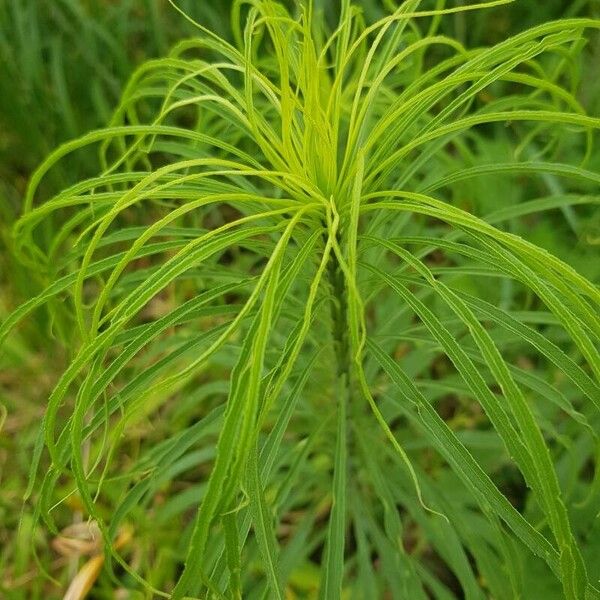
xmin=0 ymin=0 xmax=600 ymax=599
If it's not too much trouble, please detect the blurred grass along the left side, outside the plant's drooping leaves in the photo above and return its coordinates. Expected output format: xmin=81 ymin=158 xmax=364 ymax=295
xmin=0 ymin=0 xmax=229 ymax=599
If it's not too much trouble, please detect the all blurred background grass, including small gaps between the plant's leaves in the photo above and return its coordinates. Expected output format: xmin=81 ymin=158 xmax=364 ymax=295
xmin=0 ymin=0 xmax=600 ymax=598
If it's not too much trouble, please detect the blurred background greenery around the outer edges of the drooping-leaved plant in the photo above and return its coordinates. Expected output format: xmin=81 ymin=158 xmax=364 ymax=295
xmin=0 ymin=0 xmax=600 ymax=599
